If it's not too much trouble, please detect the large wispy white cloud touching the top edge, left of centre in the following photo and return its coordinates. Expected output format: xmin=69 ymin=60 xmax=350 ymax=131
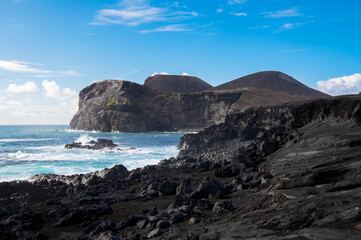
xmin=91 ymin=0 xmax=198 ymax=26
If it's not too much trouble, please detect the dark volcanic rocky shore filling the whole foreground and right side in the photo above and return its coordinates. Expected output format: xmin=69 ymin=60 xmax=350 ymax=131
xmin=0 ymin=96 xmax=361 ymax=240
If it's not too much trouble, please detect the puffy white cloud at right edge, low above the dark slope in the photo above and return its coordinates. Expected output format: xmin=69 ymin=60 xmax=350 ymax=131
xmin=317 ymin=73 xmax=361 ymax=95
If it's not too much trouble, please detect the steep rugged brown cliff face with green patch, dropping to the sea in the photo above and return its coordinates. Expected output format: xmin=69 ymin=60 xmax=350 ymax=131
xmin=70 ymin=80 xmax=241 ymax=132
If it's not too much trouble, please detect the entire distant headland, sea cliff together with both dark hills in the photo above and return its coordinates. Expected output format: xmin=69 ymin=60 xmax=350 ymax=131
xmin=70 ymin=72 xmax=327 ymax=132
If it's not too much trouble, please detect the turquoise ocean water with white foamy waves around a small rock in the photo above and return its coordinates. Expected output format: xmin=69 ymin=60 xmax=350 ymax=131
xmin=0 ymin=126 xmax=184 ymax=181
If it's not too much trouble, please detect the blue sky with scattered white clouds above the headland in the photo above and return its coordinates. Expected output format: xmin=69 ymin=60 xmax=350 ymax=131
xmin=0 ymin=0 xmax=361 ymax=125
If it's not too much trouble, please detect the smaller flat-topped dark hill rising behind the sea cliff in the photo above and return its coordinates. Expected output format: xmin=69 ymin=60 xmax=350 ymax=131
xmin=143 ymin=74 xmax=212 ymax=93
